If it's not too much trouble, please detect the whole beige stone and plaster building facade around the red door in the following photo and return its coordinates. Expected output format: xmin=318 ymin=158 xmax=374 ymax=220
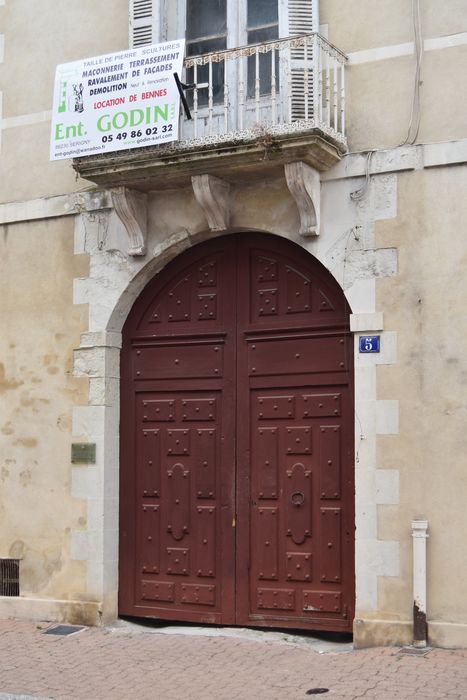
xmin=0 ymin=0 xmax=467 ymax=646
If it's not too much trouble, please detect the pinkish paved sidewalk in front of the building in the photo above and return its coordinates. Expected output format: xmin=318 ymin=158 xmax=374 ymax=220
xmin=0 ymin=620 xmax=467 ymax=700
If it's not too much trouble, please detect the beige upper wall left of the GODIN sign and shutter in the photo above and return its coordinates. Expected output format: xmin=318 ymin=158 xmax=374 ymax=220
xmin=0 ymin=0 xmax=128 ymax=202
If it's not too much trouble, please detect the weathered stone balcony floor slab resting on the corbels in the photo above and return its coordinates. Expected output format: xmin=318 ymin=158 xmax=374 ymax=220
xmin=73 ymin=127 xmax=346 ymax=191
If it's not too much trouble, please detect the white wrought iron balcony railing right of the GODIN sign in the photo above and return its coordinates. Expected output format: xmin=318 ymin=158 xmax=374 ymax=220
xmin=180 ymin=34 xmax=347 ymax=150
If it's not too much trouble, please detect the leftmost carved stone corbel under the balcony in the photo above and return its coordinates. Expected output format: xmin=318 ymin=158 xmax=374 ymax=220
xmin=112 ymin=187 xmax=148 ymax=255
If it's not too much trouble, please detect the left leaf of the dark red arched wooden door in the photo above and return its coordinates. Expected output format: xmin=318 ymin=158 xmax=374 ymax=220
xmin=119 ymin=246 xmax=235 ymax=624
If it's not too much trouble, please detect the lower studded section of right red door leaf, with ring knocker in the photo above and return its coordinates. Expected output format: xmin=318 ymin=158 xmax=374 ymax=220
xmin=237 ymin=385 xmax=353 ymax=629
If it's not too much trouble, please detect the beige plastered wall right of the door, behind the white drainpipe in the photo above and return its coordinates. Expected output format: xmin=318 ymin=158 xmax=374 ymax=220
xmin=377 ymin=166 xmax=467 ymax=636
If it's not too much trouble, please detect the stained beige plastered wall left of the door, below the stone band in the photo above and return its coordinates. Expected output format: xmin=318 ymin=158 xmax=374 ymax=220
xmin=0 ymin=219 xmax=91 ymax=616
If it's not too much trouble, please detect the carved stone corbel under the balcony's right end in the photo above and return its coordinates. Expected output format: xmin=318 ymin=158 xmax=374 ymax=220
xmin=284 ymin=161 xmax=321 ymax=236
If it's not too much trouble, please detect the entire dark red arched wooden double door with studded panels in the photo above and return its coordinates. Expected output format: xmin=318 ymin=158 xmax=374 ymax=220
xmin=120 ymin=234 xmax=354 ymax=630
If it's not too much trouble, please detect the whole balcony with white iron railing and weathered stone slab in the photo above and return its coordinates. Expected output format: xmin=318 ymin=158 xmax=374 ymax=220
xmin=73 ymin=34 xmax=347 ymax=190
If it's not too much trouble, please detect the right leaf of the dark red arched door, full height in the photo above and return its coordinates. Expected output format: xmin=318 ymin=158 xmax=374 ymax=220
xmin=236 ymin=235 xmax=354 ymax=631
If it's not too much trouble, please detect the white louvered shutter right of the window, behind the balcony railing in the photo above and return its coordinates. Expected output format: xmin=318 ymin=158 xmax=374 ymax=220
xmin=287 ymin=0 xmax=319 ymax=121
